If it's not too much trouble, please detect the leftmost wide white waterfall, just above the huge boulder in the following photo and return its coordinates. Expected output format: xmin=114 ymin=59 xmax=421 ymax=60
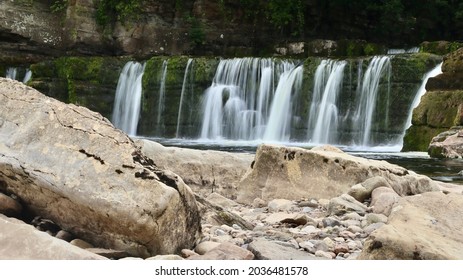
xmin=112 ymin=61 xmax=145 ymax=135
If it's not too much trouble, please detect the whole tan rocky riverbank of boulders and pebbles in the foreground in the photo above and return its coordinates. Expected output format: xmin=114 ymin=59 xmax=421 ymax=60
xmin=0 ymin=79 xmax=463 ymax=260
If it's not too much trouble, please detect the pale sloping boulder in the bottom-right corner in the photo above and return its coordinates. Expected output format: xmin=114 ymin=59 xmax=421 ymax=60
xmin=359 ymin=192 xmax=463 ymax=260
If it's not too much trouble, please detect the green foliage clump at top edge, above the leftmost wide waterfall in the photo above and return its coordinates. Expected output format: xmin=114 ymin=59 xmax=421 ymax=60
xmin=96 ymin=0 xmax=143 ymax=26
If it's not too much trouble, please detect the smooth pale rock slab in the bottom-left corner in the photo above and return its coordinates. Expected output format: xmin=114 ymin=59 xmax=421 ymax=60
xmin=0 ymin=214 xmax=106 ymax=260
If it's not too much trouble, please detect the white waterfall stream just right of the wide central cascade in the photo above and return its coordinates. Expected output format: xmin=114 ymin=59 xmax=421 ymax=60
xmin=308 ymin=60 xmax=347 ymax=144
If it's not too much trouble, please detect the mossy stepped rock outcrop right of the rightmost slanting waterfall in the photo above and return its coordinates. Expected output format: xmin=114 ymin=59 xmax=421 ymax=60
xmin=403 ymin=48 xmax=463 ymax=151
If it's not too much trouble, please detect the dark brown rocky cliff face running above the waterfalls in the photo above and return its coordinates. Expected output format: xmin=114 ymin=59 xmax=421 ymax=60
xmin=0 ymin=0 xmax=459 ymax=65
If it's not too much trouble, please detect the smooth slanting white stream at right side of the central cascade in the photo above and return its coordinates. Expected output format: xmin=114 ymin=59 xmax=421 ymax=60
xmin=263 ymin=66 xmax=303 ymax=141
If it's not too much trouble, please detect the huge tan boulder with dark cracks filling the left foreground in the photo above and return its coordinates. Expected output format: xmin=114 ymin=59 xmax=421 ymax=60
xmin=0 ymin=78 xmax=200 ymax=257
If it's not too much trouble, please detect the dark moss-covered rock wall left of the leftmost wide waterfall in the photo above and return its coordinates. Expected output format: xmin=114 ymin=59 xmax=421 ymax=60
xmin=29 ymin=57 xmax=129 ymax=118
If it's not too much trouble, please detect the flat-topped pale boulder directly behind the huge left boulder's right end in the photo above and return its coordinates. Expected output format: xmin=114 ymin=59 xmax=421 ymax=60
xmin=136 ymin=139 xmax=254 ymax=198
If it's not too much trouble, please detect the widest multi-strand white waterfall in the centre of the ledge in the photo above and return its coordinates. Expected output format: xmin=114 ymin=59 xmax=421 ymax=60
xmin=200 ymin=58 xmax=294 ymax=140
